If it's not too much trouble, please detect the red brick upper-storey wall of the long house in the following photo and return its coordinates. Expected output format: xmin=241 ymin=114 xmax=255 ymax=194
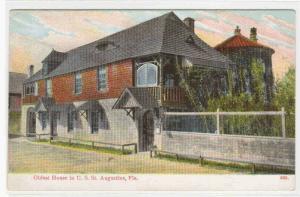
xmin=23 ymin=60 xmax=133 ymax=103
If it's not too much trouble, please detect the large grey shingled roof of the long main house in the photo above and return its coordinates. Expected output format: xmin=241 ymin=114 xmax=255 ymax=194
xmin=26 ymin=12 xmax=232 ymax=82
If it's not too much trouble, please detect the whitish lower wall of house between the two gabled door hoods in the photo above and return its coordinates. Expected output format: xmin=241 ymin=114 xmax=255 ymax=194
xmin=53 ymin=99 xmax=138 ymax=144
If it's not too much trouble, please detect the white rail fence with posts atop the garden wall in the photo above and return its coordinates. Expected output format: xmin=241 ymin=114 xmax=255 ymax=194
xmin=164 ymin=107 xmax=286 ymax=138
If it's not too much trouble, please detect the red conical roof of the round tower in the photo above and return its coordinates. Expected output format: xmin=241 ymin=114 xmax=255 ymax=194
xmin=215 ymin=33 xmax=274 ymax=53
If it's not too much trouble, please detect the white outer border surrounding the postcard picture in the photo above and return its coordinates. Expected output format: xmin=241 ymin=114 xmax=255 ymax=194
xmin=0 ymin=0 xmax=300 ymax=196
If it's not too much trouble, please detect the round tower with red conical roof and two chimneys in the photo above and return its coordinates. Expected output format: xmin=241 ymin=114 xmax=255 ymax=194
xmin=215 ymin=26 xmax=275 ymax=103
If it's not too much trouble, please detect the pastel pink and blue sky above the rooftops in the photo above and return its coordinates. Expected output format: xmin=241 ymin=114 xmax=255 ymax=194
xmin=9 ymin=10 xmax=296 ymax=80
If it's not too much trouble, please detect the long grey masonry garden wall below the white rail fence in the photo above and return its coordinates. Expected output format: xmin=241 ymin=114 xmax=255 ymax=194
xmin=161 ymin=131 xmax=295 ymax=168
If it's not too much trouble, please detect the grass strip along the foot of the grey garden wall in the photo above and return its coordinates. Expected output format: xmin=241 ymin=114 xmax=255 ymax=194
xmin=155 ymin=153 xmax=295 ymax=174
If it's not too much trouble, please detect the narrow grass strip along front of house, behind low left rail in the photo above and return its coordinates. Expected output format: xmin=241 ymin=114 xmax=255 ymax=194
xmin=36 ymin=139 xmax=132 ymax=155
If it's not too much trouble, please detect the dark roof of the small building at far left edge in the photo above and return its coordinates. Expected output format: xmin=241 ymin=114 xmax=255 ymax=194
xmin=8 ymin=72 xmax=27 ymax=94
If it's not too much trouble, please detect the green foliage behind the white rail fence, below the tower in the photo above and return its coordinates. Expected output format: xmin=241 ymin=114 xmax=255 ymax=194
xmin=207 ymin=60 xmax=295 ymax=137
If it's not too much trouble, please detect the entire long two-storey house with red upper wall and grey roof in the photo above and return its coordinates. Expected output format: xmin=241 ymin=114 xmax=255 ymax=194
xmin=22 ymin=12 xmax=231 ymax=151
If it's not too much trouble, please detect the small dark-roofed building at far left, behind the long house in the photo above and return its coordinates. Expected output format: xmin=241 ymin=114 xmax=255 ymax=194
xmin=8 ymin=72 xmax=27 ymax=112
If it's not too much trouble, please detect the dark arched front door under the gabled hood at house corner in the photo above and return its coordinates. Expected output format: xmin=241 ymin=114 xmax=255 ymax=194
xmin=141 ymin=111 xmax=154 ymax=151
